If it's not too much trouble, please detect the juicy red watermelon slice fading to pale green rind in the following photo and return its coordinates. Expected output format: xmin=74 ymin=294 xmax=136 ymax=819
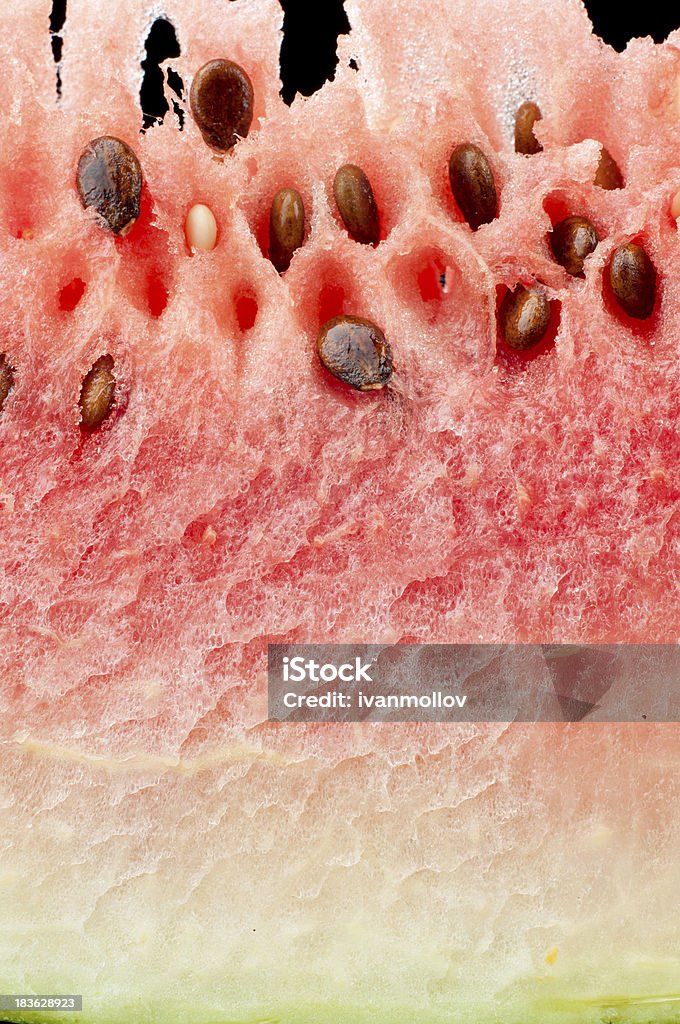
xmin=0 ymin=0 xmax=680 ymax=1024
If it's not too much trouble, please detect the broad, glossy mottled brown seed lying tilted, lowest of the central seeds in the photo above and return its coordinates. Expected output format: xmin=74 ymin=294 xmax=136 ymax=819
xmin=316 ymin=316 xmax=392 ymax=391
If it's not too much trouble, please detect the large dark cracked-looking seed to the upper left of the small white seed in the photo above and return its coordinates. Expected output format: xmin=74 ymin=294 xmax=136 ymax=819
xmin=76 ymin=135 xmax=142 ymax=236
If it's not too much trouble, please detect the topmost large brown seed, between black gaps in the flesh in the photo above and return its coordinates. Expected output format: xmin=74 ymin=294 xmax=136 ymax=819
xmin=188 ymin=59 xmax=253 ymax=153
